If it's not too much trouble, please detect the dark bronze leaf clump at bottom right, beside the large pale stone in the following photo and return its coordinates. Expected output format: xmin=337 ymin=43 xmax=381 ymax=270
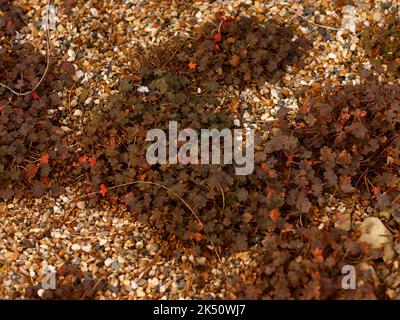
xmin=236 ymin=227 xmax=382 ymax=300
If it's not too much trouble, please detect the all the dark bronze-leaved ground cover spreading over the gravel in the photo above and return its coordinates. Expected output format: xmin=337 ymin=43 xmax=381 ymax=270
xmin=0 ymin=0 xmax=400 ymax=299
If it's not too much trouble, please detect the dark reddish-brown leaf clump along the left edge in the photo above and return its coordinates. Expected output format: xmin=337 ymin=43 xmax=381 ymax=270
xmin=0 ymin=44 xmax=74 ymax=199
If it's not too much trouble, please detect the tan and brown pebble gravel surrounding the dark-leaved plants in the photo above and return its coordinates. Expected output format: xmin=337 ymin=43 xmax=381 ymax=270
xmin=0 ymin=0 xmax=399 ymax=299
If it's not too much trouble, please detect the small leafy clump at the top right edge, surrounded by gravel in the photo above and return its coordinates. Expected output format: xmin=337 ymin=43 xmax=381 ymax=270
xmin=361 ymin=12 xmax=400 ymax=77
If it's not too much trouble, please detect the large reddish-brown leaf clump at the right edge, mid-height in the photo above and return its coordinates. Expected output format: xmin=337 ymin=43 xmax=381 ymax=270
xmin=265 ymin=80 xmax=400 ymax=213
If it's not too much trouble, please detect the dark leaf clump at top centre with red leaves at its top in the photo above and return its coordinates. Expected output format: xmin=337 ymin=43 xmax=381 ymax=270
xmin=136 ymin=16 xmax=310 ymax=88
